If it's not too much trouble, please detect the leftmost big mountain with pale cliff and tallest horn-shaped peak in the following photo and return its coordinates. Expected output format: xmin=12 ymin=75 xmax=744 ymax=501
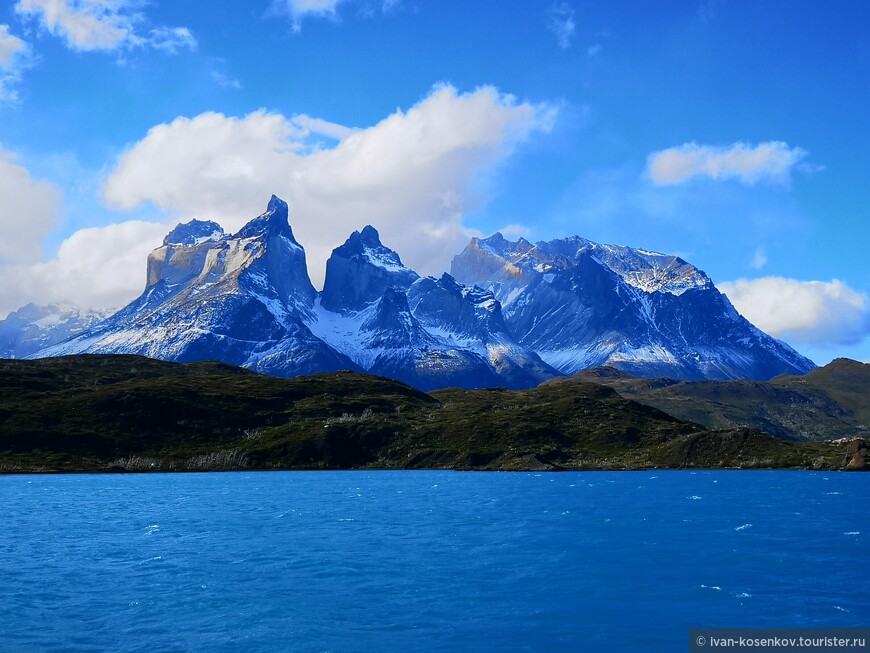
xmin=39 ymin=197 xmax=359 ymax=376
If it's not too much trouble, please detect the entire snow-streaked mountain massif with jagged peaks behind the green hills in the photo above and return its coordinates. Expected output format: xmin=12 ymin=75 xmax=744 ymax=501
xmin=29 ymin=196 xmax=814 ymax=390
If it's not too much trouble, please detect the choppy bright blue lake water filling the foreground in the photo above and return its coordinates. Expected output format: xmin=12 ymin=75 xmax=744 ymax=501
xmin=0 ymin=471 xmax=870 ymax=652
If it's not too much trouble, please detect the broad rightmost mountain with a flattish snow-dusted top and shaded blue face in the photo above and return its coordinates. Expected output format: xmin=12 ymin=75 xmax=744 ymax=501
xmin=452 ymin=234 xmax=814 ymax=380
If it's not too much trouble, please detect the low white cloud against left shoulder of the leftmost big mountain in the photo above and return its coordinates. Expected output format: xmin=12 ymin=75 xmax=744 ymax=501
xmin=0 ymin=220 xmax=169 ymax=315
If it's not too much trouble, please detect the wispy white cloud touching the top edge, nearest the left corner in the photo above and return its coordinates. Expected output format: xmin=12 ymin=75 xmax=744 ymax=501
xmin=15 ymin=0 xmax=196 ymax=52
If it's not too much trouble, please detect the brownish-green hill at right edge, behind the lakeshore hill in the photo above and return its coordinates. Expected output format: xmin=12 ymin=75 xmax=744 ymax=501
xmin=564 ymin=358 xmax=870 ymax=440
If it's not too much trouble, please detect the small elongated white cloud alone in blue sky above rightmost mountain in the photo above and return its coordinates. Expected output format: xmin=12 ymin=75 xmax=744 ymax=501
xmin=646 ymin=141 xmax=807 ymax=186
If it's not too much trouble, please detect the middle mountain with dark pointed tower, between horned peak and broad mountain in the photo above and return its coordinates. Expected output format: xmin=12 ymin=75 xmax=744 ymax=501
xmin=311 ymin=226 xmax=557 ymax=390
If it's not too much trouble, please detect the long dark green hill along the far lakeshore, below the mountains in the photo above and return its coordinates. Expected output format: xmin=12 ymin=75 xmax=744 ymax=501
xmin=0 ymin=355 xmax=860 ymax=473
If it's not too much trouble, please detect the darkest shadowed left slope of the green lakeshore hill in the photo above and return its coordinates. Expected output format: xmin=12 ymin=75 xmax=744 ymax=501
xmin=0 ymin=355 xmax=437 ymax=469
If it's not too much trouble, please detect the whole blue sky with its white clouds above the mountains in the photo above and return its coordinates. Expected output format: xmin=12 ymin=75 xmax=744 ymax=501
xmin=0 ymin=0 xmax=870 ymax=363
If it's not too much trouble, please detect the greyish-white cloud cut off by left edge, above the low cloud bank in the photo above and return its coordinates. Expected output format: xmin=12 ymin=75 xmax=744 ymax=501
xmin=0 ymin=148 xmax=61 ymax=264
